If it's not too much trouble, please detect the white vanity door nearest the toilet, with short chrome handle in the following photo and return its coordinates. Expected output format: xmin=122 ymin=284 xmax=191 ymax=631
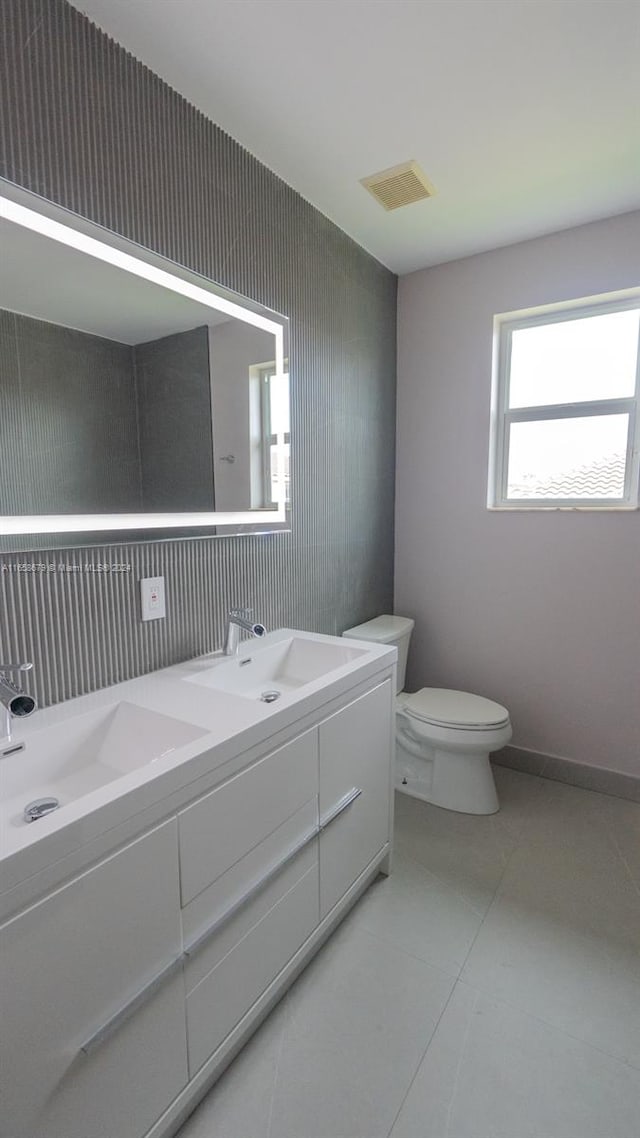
xmin=319 ymin=679 xmax=393 ymax=920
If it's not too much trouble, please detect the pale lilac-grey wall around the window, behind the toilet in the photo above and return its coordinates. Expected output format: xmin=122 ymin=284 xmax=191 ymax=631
xmin=395 ymin=213 xmax=640 ymax=775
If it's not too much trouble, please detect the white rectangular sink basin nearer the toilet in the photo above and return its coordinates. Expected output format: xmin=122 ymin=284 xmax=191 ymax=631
xmin=182 ymin=636 xmax=368 ymax=704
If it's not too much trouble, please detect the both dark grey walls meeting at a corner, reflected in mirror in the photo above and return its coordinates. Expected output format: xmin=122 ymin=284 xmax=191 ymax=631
xmin=0 ymin=311 xmax=215 ymax=516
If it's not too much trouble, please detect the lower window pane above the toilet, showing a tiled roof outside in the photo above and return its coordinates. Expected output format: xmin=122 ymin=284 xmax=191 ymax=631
xmin=507 ymin=414 xmax=629 ymax=500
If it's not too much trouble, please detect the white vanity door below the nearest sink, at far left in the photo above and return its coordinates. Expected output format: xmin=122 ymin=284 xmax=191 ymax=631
xmin=0 ymin=819 xmax=187 ymax=1138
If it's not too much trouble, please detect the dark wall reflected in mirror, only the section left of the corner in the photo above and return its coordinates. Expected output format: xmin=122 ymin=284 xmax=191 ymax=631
xmin=0 ymin=311 xmax=141 ymax=514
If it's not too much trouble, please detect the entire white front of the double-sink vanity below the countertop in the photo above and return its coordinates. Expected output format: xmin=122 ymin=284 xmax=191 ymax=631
xmin=0 ymin=668 xmax=393 ymax=1138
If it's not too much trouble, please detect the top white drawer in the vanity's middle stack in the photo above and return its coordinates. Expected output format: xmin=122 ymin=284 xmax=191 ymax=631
xmin=178 ymin=731 xmax=318 ymax=906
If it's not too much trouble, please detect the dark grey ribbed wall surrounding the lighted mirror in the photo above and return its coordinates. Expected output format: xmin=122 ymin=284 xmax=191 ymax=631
xmin=0 ymin=0 xmax=396 ymax=704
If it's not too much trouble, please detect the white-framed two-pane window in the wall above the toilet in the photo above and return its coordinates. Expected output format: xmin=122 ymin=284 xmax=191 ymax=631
xmin=487 ymin=289 xmax=640 ymax=509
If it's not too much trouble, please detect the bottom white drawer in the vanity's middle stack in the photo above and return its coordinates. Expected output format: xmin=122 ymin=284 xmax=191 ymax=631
xmin=187 ymin=860 xmax=319 ymax=1078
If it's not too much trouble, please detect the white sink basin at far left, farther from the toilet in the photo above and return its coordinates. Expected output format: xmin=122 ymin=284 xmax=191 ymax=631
xmin=0 ymin=701 xmax=206 ymax=827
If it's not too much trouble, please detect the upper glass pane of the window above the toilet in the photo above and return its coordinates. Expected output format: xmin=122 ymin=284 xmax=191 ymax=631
xmin=509 ymin=310 xmax=640 ymax=407
